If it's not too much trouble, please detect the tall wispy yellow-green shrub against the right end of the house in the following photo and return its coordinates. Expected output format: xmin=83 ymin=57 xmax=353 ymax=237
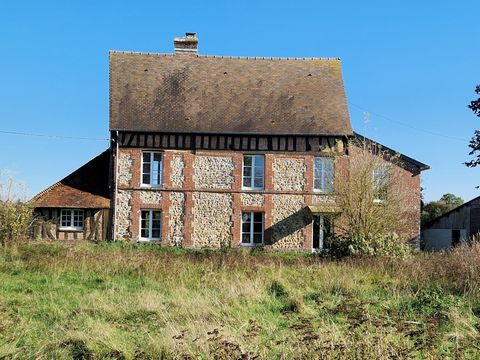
xmin=336 ymin=140 xmax=409 ymax=254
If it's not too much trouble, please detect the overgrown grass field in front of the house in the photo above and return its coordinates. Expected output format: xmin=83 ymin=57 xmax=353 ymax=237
xmin=0 ymin=243 xmax=480 ymax=359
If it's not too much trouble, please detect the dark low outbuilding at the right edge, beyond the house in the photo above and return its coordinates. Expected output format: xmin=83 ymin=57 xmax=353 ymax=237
xmin=421 ymin=196 xmax=480 ymax=250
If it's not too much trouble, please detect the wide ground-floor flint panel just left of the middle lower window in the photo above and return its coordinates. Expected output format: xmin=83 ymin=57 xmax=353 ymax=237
xmin=192 ymin=192 xmax=233 ymax=248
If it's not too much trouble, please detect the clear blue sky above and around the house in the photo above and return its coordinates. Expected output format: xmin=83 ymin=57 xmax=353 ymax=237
xmin=0 ymin=0 xmax=480 ymax=200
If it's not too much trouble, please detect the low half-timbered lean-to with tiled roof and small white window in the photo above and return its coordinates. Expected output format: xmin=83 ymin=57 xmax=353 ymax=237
xmin=32 ymin=150 xmax=110 ymax=240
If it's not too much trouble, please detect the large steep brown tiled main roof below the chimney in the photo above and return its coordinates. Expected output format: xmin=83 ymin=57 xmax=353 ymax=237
xmin=110 ymin=51 xmax=352 ymax=135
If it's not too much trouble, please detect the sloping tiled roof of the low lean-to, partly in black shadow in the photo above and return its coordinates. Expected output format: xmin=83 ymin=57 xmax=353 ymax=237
xmin=32 ymin=150 xmax=110 ymax=209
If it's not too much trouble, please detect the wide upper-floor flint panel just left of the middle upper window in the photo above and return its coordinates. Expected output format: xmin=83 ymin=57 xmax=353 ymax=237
xmin=193 ymin=156 xmax=234 ymax=189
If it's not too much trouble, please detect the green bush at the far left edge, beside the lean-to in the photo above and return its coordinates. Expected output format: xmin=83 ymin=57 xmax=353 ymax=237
xmin=0 ymin=173 xmax=34 ymax=245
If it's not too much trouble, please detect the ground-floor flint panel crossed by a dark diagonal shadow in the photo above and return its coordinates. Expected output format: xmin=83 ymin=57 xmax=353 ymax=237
xmin=271 ymin=195 xmax=309 ymax=249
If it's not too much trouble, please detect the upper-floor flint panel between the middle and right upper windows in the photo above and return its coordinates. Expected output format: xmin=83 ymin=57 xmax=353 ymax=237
xmin=273 ymin=158 xmax=307 ymax=191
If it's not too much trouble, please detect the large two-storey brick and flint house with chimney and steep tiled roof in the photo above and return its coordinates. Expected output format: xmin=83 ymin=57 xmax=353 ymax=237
xmin=31 ymin=33 xmax=428 ymax=251
